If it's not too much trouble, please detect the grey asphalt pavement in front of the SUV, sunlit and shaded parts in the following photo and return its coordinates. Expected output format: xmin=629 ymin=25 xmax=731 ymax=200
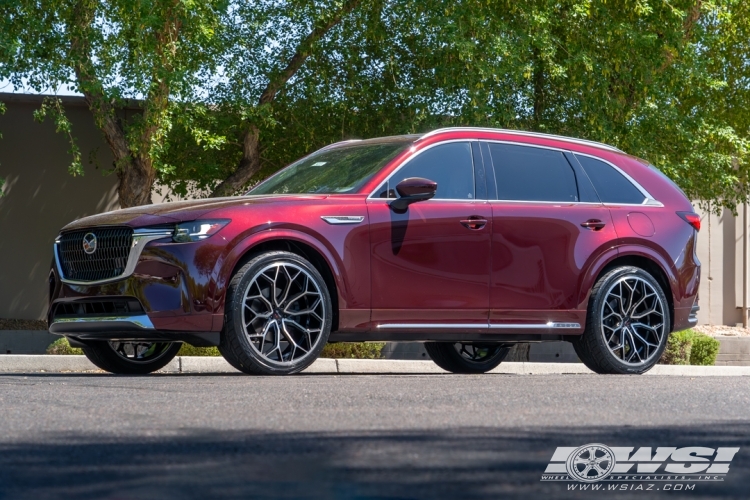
xmin=0 ymin=373 xmax=750 ymax=499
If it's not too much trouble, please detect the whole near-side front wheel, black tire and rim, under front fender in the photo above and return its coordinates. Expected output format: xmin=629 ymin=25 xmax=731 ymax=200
xmin=219 ymin=251 xmax=333 ymax=375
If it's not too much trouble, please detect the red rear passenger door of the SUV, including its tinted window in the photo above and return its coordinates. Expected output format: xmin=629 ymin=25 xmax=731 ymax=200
xmin=482 ymin=142 xmax=615 ymax=333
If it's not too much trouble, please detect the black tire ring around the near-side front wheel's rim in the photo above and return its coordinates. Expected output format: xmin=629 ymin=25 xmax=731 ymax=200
xmin=225 ymin=252 xmax=333 ymax=375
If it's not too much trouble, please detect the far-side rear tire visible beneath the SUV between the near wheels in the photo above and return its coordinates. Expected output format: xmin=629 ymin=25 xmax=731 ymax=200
xmin=424 ymin=342 xmax=510 ymax=373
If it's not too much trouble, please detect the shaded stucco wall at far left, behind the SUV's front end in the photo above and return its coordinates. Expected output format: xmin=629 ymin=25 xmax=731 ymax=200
xmin=0 ymin=95 xmax=117 ymax=319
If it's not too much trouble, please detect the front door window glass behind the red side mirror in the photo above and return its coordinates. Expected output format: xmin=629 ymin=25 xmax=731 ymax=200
xmin=389 ymin=142 xmax=474 ymax=200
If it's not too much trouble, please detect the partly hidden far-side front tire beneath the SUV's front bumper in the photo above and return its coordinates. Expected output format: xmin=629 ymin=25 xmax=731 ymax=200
xmin=82 ymin=341 xmax=182 ymax=375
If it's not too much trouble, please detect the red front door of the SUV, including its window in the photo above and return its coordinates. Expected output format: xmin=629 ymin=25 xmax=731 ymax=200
xmin=368 ymin=142 xmax=492 ymax=329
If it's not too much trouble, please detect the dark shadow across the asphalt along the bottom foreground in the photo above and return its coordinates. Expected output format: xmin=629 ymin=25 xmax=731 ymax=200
xmin=0 ymin=422 xmax=750 ymax=500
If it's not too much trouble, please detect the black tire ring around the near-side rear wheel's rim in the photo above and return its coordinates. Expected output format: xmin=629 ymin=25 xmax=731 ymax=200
xmin=589 ymin=267 xmax=671 ymax=374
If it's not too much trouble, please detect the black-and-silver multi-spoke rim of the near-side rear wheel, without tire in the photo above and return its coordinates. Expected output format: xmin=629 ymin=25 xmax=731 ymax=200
xmin=601 ymin=276 xmax=665 ymax=365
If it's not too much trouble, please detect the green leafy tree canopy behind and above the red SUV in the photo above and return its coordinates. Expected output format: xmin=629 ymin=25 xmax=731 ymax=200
xmin=0 ymin=0 xmax=750 ymax=209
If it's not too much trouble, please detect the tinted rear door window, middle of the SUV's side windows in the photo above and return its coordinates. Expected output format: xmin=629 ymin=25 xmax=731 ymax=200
xmin=489 ymin=143 xmax=578 ymax=202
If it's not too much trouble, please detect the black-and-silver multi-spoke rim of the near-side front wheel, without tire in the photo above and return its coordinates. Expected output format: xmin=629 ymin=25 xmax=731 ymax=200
xmin=243 ymin=262 xmax=326 ymax=364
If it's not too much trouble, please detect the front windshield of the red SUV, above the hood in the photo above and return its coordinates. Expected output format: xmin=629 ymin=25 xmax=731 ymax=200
xmin=247 ymin=140 xmax=413 ymax=194
